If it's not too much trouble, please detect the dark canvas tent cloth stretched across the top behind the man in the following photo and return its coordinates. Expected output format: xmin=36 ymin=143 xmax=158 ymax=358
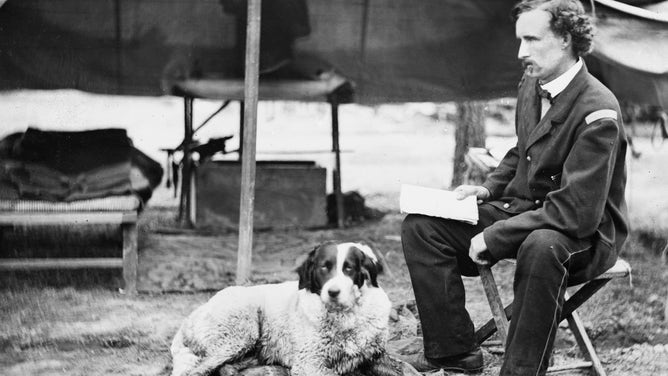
xmin=0 ymin=0 xmax=668 ymax=280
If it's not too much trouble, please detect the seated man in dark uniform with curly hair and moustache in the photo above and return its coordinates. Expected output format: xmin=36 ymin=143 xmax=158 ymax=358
xmin=402 ymin=0 xmax=628 ymax=375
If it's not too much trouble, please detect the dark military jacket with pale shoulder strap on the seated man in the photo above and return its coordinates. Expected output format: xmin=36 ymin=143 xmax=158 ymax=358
xmin=483 ymin=66 xmax=629 ymax=283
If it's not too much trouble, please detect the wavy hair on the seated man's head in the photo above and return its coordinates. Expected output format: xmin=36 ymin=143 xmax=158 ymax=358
xmin=511 ymin=0 xmax=594 ymax=56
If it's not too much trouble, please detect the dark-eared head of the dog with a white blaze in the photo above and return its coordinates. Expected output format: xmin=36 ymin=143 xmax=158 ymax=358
xmin=297 ymin=242 xmax=382 ymax=308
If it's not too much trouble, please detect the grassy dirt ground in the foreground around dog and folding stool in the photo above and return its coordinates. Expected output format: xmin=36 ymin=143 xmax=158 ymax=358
xmin=0 ymin=213 xmax=668 ymax=376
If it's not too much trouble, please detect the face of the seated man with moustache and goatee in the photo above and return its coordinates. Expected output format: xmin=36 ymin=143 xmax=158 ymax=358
xmin=515 ymin=9 xmax=573 ymax=82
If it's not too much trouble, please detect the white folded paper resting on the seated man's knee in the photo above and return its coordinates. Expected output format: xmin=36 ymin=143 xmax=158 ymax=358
xmin=399 ymin=184 xmax=478 ymax=225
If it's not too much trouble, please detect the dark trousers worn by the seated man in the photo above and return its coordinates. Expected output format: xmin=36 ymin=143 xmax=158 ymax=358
xmin=401 ymin=203 xmax=591 ymax=375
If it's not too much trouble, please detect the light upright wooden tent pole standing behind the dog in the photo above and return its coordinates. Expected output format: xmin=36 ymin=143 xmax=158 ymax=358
xmin=236 ymin=0 xmax=262 ymax=285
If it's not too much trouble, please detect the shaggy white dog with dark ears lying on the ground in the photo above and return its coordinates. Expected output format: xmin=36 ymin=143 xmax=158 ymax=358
xmin=170 ymin=242 xmax=403 ymax=376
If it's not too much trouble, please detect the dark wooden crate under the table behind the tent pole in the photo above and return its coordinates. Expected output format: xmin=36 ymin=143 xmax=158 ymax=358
xmin=196 ymin=161 xmax=327 ymax=229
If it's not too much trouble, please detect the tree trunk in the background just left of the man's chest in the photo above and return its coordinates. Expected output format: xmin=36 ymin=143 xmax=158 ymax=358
xmin=452 ymin=101 xmax=486 ymax=188
